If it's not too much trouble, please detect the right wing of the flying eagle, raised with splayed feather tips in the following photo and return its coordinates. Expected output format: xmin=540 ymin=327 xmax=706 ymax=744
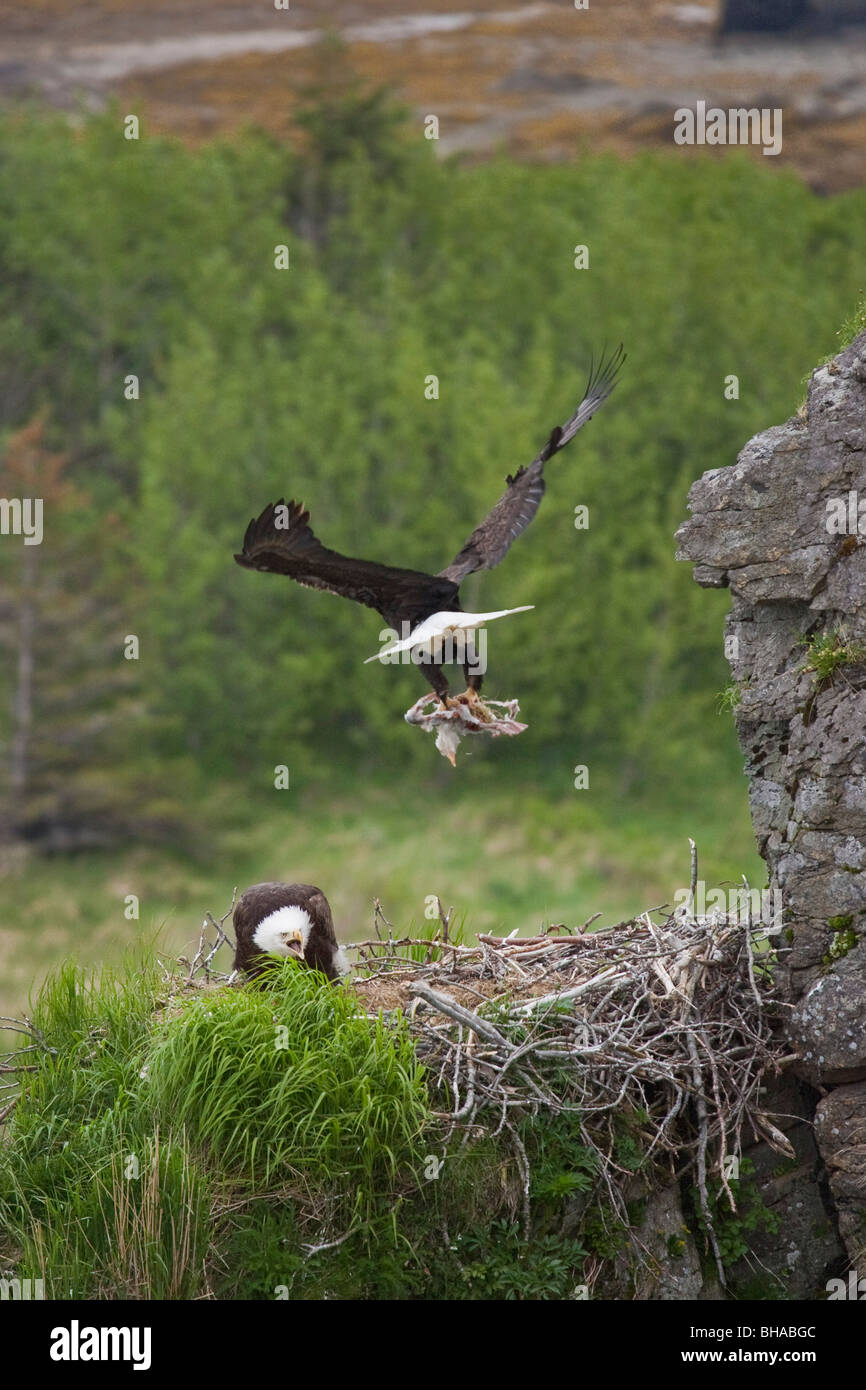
xmin=439 ymin=345 xmax=626 ymax=584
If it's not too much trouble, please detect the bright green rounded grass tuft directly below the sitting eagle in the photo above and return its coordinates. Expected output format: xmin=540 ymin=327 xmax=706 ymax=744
xmin=147 ymin=960 xmax=430 ymax=1218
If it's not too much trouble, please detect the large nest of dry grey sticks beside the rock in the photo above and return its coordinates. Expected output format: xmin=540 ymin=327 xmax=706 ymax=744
xmin=350 ymin=851 xmax=795 ymax=1286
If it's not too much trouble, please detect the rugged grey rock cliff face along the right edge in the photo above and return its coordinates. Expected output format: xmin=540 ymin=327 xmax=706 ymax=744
xmin=677 ymin=334 xmax=866 ymax=1273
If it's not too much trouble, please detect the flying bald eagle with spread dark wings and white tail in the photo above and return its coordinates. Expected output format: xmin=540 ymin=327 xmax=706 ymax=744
xmin=235 ymin=346 xmax=626 ymax=706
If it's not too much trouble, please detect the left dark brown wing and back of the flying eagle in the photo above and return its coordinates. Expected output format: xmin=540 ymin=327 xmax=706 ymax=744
xmin=235 ymin=499 xmax=457 ymax=627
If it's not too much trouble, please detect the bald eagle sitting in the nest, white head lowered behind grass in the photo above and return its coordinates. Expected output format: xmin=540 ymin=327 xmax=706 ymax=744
xmin=232 ymin=883 xmax=349 ymax=980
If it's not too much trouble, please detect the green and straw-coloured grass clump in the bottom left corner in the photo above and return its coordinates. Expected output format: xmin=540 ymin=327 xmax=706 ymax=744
xmin=0 ymin=954 xmax=210 ymax=1298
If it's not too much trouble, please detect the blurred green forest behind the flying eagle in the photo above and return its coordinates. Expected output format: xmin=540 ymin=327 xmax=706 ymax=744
xmin=0 ymin=89 xmax=866 ymax=1006
